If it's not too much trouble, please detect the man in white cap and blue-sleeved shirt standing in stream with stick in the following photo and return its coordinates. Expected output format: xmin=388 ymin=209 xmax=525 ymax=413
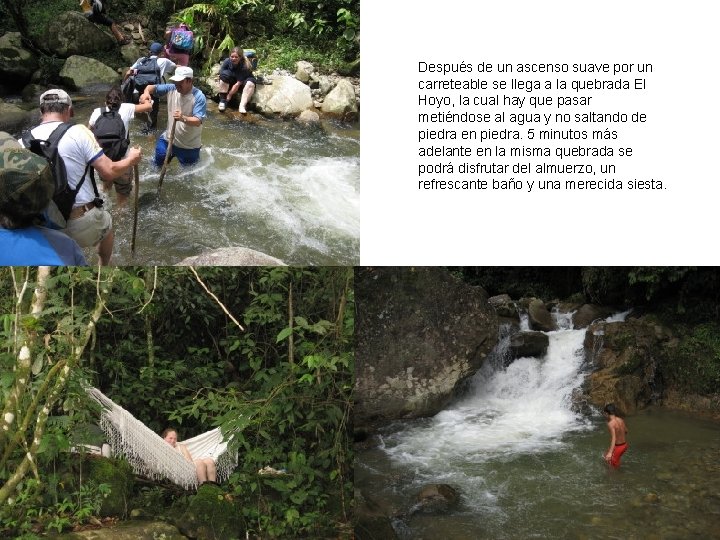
xmin=140 ymin=66 xmax=207 ymax=167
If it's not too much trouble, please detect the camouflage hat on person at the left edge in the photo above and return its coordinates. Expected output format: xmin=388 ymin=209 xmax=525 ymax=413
xmin=0 ymin=132 xmax=55 ymax=216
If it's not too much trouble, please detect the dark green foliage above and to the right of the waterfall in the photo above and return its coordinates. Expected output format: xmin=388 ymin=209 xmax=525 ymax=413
xmin=449 ymin=266 xmax=720 ymax=395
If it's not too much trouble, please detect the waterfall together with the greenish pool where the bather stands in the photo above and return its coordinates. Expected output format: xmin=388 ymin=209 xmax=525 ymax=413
xmin=362 ymin=313 xmax=720 ymax=540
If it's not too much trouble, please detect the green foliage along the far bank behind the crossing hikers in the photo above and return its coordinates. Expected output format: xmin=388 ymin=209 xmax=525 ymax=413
xmin=0 ymin=0 xmax=360 ymax=76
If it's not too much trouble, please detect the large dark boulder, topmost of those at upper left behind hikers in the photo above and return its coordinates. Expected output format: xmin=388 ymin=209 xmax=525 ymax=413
xmin=44 ymin=11 xmax=118 ymax=58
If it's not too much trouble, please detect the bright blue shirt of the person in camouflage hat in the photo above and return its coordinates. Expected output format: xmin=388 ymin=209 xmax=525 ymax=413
xmin=0 ymin=227 xmax=87 ymax=266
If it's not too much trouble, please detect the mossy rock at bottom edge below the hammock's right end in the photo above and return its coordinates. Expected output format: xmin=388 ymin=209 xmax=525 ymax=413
xmin=175 ymin=484 xmax=244 ymax=540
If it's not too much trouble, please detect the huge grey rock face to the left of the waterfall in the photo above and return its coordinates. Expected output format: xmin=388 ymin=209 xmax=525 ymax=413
xmin=355 ymin=268 xmax=498 ymax=427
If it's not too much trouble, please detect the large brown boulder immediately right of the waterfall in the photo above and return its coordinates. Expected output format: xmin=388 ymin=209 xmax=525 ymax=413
xmin=584 ymin=319 xmax=672 ymax=414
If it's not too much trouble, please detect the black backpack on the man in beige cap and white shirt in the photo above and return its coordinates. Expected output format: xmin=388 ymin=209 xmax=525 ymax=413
xmin=22 ymin=122 xmax=94 ymax=220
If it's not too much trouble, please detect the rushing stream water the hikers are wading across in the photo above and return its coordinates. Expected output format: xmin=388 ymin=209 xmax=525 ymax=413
xmin=59 ymin=96 xmax=360 ymax=266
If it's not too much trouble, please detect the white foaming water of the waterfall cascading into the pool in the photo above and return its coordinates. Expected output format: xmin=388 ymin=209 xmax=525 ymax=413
xmin=385 ymin=315 xmax=632 ymax=472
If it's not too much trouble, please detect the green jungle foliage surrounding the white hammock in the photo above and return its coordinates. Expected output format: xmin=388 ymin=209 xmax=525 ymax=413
xmin=0 ymin=267 xmax=355 ymax=538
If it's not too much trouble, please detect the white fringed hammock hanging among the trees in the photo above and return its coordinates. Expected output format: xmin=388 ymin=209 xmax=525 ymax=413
xmin=87 ymin=388 xmax=238 ymax=489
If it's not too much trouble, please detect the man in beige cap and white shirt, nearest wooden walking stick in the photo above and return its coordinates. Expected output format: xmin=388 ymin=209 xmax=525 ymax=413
xmin=21 ymin=89 xmax=141 ymax=265
